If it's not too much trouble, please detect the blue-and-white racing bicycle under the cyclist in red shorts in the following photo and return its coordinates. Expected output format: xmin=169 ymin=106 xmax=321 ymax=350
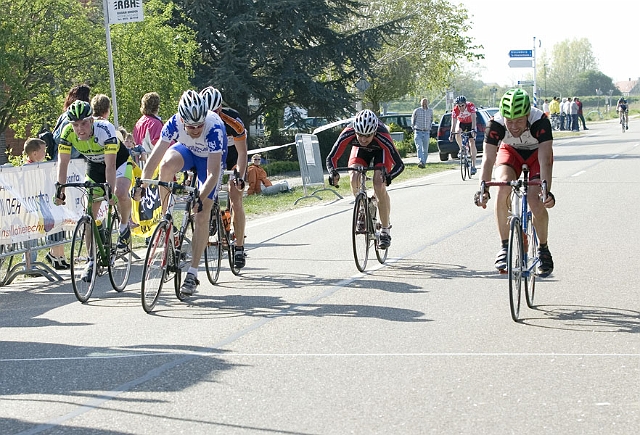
xmin=480 ymin=165 xmax=547 ymax=322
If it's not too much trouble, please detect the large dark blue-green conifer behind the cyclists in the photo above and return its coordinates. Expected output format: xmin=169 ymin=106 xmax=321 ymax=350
xmin=174 ymin=0 xmax=398 ymax=135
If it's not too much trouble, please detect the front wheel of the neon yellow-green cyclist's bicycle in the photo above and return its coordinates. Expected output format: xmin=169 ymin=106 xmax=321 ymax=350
xmin=70 ymin=215 xmax=100 ymax=303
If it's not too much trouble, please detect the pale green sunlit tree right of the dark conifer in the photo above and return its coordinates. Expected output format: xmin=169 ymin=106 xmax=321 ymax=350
xmin=357 ymin=0 xmax=482 ymax=110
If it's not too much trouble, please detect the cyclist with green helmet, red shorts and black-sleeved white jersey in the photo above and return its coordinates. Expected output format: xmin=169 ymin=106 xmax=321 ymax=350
xmin=474 ymin=89 xmax=556 ymax=278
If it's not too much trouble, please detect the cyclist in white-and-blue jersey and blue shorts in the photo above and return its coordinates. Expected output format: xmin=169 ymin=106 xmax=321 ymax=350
xmin=136 ymin=90 xmax=227 ymax=295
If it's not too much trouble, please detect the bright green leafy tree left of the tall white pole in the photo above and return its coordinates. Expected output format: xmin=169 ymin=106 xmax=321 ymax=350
xmin=0 ymin=0 xmax=106 ymax=138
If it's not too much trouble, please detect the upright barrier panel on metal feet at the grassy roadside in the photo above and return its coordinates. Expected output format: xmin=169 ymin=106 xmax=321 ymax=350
xmin=294 ymin=133 xmax=342 ymax=205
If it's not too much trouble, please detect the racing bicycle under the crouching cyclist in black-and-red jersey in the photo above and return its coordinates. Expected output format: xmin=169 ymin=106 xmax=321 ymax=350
xmin=334 ymin=166 xmax=389 ymax=272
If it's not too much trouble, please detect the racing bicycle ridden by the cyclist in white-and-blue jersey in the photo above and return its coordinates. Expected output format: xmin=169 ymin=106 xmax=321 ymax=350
xmin=136 ymin=171 xmax=199 ymax=313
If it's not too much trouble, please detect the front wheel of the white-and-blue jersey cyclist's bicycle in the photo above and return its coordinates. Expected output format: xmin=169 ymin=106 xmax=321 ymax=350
xmin=141 ymin=220 xmax=173 ymax=313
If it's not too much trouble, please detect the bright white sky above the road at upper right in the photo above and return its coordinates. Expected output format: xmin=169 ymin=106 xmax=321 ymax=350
xmin=457 ymin=0 xmax=640 ymax=87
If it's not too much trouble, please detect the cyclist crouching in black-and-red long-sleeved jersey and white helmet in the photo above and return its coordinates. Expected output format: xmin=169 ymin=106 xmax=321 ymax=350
xmin=327 ymin=109 xmax=404 ymax=249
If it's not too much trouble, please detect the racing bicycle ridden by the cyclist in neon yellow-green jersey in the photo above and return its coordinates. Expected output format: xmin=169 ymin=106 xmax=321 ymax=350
xmin=56 ymin=181 xmax=132 ymax=303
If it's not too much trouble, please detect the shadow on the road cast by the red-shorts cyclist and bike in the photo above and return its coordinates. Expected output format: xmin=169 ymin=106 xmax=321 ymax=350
xmin=521 ymin=305 xmax=640 ymax=334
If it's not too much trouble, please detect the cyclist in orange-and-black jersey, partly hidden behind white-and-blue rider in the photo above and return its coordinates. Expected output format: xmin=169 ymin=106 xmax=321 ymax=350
xmin=200 ymin=86 xmax=248 ymax=269
